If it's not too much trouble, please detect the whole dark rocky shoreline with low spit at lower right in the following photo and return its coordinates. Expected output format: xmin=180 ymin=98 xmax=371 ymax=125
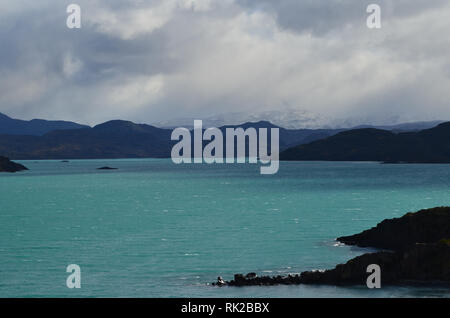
xmin=213 ymin=207 xmax=450 ymax=287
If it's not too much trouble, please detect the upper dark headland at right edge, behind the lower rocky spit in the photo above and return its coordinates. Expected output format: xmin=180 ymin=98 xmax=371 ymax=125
xmin=337 ymin=207 xmax=450 ymax=250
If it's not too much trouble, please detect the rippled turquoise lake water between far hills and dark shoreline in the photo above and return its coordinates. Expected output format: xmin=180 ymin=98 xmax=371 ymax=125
xmin=0 ymin=159 xmax=450 ymax=297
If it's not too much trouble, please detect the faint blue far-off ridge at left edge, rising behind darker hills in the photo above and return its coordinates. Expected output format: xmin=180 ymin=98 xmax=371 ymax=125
xmin=0 ymin=113 xmax=89 ymax=136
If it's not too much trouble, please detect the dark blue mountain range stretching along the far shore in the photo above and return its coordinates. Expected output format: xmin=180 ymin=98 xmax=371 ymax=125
xmin=0 ymin=114 xmax=450 ymax=163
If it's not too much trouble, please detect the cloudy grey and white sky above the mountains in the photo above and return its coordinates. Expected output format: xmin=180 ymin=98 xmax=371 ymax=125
xmin=0 ymin=0 xmax=450 ymax=125
